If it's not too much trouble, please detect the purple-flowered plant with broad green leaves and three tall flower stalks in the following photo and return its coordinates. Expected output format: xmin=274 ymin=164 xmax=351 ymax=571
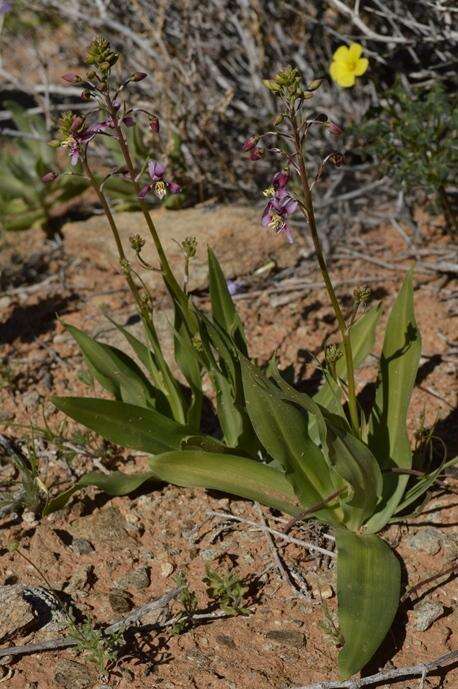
xmin=40 ymin=38 xmax=458 ymax=677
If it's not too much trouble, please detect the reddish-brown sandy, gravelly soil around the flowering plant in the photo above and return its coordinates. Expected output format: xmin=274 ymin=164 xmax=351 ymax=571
xmin=0 ymin=206 xmax=457 ymax=689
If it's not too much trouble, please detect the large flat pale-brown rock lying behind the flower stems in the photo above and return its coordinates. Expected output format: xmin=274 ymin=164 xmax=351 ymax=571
xmin=64 ymin=204 xmax=304 ymax=293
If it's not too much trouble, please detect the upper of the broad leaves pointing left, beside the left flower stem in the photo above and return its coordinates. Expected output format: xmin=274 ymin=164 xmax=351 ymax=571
xmin=64 ymin=323 xmax=156 ymax=408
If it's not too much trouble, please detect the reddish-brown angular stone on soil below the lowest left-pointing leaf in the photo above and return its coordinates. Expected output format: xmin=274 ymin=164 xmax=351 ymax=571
xmin=68 ymin=506 xmax=131 ymax=548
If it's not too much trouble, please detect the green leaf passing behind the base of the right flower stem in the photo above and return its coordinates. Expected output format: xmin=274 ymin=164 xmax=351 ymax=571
xmin=313 ymin=305 xmax=380 ymax=414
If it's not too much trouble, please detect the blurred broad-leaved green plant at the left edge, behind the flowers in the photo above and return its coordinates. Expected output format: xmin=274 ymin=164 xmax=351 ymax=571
xmin=0 ymin=101 xmax=88 ymax=237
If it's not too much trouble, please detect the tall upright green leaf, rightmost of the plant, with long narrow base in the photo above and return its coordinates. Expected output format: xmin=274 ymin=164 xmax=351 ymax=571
xmin=366 ymin=271 xmax=421 ymax=533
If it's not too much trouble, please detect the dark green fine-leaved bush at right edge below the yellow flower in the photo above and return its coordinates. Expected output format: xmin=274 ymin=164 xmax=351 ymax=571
xmin=353 ymin=81 xmax=458 ymax=231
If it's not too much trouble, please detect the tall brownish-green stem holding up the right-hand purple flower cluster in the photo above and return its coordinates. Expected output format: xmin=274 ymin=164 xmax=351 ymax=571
xmin=290 ymin=113 xmax=360 ymax=437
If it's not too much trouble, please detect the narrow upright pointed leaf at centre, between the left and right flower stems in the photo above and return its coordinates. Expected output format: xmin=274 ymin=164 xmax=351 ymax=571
xmin=208 ymin=247 xmax=247 ymax=355
